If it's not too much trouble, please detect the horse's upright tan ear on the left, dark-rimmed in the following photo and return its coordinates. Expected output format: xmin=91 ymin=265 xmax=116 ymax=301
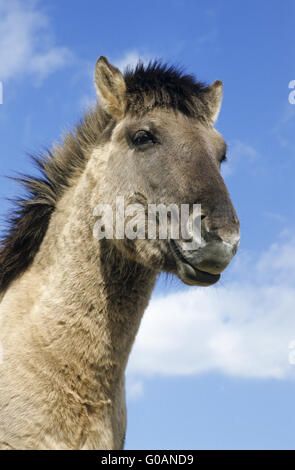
xmin=94 ymin=56 xmax=126 ymax=119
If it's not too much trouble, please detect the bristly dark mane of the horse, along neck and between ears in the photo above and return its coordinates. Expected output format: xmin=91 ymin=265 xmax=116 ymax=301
xmin=0 ymin=61 xmax=206 ymax=294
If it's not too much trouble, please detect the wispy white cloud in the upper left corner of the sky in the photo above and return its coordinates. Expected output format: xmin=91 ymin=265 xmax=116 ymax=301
xmin=0 ymin=0 xmax=72 ymax=82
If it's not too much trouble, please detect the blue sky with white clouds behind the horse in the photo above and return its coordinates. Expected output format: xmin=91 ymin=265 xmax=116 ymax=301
xmin=0 ymin=0 xmax=295 ymax=449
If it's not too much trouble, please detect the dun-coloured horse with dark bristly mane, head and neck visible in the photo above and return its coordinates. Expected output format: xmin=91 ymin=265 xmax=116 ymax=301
xmin=0 ymin=56 xmax=240 ymax=450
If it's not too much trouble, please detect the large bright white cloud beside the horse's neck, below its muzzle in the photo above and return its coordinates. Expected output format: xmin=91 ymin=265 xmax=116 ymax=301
xmin=128 ymin=235 xmax=295 ymax=379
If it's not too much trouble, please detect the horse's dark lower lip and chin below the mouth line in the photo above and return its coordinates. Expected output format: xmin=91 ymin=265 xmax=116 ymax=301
xmin=170 ymin=239 xmax=220 ymax=286
